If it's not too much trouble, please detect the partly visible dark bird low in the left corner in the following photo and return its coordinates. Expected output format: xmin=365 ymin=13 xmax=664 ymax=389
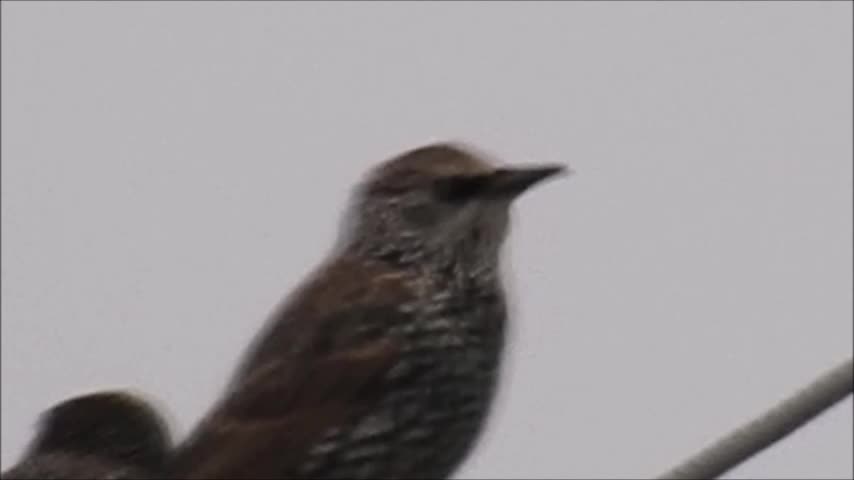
xmin=0 ymin=390 xmax=172 ymax=480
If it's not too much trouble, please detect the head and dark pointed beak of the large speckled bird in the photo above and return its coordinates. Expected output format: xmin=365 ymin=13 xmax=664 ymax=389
xmin=345 ymin=143 xmax=565 ymax=270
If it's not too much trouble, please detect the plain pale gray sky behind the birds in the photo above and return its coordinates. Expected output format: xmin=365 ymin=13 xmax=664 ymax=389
xmin=2 ymin=2 xmax=852 ymax=478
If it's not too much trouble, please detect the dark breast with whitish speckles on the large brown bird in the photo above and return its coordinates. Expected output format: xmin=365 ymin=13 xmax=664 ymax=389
xmin=300 ymin=288 xmax=506 ymax=478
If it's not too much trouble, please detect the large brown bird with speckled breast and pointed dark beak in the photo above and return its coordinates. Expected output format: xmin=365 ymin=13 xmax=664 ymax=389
xmin=170 ymin=143 xmax=564 ymax=479
